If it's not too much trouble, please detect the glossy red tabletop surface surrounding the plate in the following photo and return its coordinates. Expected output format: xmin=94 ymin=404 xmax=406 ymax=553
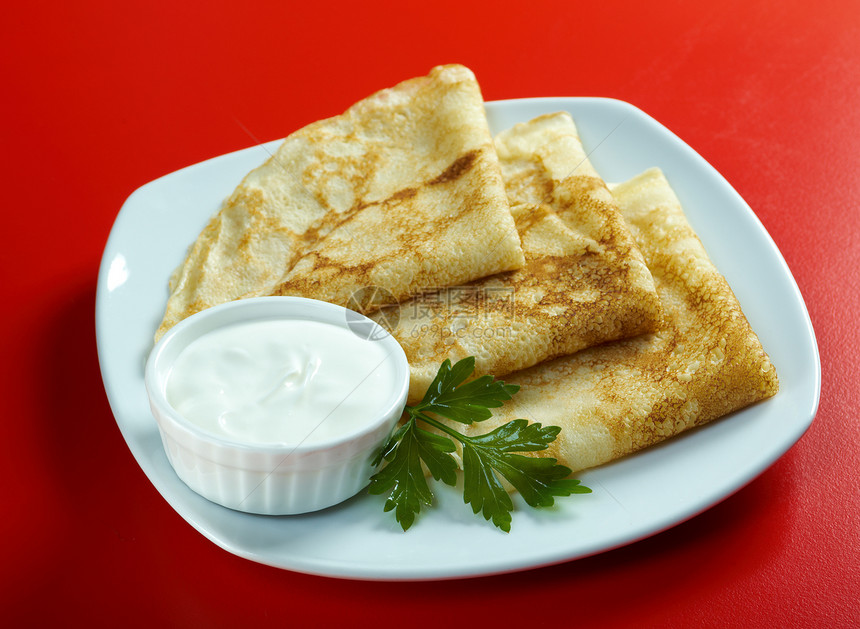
xmin=0 ymin=0 xmax=860 ymax=627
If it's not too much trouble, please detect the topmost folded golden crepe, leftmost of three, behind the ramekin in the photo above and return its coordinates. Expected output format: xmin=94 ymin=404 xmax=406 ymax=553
xmin=156 ymin=65 xmax=524 ymax=339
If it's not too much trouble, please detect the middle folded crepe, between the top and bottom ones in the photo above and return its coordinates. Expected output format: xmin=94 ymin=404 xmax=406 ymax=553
xmin=376 ymin=112 xmax=661 ymax=403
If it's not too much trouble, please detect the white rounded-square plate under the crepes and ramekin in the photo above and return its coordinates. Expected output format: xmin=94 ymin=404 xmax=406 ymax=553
xmin=96 ymin=98 xmax=821 ymax=579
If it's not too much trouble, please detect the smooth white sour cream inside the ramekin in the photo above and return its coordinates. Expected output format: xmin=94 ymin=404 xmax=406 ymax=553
xmin=167 ymin=319 xmax=396 ymax=446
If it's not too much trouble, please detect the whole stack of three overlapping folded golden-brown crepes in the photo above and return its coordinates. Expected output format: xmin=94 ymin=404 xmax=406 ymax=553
xmin=156 ymin=66 xmax=778 ymax=471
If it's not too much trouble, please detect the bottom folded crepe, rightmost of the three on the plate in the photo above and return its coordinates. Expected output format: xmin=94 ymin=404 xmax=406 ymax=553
xmin=456 ymin=169 xmax=779 ymax=471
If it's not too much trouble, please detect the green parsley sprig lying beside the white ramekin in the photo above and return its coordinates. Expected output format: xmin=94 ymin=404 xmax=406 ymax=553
xmin=369 ymin=356 xmax=591 ymax=532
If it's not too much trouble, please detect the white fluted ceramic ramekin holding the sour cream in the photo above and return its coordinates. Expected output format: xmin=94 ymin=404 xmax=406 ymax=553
xmin=145 ymin=297 xmax=409 ymax=515
